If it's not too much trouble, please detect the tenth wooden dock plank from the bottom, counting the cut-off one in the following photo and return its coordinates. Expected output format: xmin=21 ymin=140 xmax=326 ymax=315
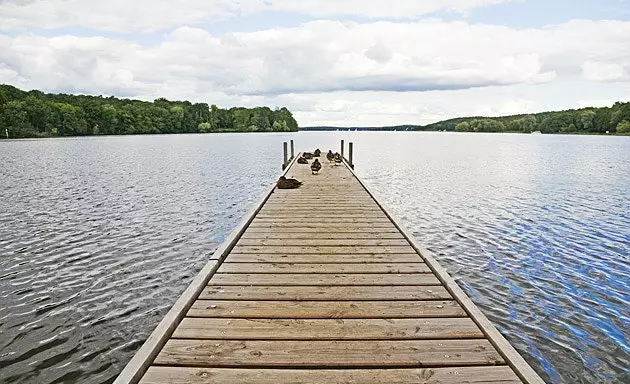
xmin=238 ymin=237 xmax=409 ymax=247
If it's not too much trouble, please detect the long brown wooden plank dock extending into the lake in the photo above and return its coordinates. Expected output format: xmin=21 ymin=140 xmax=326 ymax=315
xmin=116 ymin=148 xmax=543 ymax=384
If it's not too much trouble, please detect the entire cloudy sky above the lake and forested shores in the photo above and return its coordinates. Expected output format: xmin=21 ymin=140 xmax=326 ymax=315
xmin=0 ymin=0 xmax=630 ymax=126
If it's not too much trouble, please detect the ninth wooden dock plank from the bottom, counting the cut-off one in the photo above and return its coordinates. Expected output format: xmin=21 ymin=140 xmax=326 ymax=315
xmin=233 ymin=245 xmax=420 ymax=255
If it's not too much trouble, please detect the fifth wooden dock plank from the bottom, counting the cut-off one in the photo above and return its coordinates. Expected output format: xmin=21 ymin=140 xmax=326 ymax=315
xmin=199 ymin=285 xmax=451 ymax=301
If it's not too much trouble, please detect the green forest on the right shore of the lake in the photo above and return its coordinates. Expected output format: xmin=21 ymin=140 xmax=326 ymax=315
xmin=420 ymin=103 xmax=630 ymax=135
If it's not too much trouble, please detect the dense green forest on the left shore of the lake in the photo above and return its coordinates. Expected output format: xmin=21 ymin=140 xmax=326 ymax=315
xmin=0 ymin=84 xmax=298 ymax=138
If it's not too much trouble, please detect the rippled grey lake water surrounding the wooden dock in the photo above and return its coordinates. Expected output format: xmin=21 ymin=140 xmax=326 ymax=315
xmin=0 ymin=132 xmax=630 ymax=383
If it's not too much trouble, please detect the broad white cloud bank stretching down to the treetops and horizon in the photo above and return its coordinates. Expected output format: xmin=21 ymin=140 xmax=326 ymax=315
xmin=0 ymin=20 xmax=630 ymax=125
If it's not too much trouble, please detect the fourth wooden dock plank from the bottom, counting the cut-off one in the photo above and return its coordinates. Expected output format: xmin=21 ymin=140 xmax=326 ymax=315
xmin=186 ymin=300 xmax=466 ymax=319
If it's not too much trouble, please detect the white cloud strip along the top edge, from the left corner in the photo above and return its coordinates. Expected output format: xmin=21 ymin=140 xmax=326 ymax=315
xmin=0 ymin=0 xmax=515 ymax=32
